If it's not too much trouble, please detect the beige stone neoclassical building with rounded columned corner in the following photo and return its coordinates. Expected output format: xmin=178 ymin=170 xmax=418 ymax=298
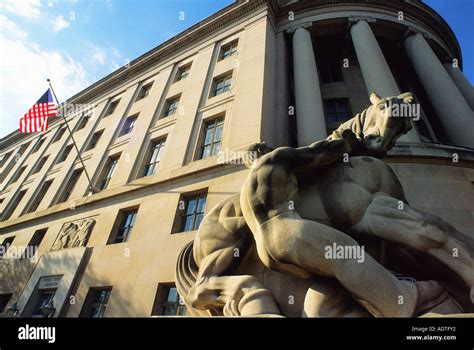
xmin=0 ymin=0 xmax=474 ymax=317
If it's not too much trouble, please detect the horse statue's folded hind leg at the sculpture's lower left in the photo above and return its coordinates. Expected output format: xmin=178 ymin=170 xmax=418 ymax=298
xmin=188 ymin=248 xmax=281 ymax=316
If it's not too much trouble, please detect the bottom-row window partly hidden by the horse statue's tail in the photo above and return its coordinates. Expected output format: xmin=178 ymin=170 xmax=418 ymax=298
xmin=151 ymin=285 xmax=187 ymax=316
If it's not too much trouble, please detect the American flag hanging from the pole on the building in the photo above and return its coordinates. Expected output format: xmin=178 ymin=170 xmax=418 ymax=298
xmin=20 ymin=89 xmax=57 ymax=132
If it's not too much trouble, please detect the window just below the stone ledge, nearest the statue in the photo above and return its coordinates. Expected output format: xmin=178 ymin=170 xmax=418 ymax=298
xmin=178 ymin=193 xmax=207 ymax=232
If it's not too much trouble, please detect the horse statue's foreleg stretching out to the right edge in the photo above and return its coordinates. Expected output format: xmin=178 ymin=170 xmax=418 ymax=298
xmin=351 ymin=194 xmax=474 ymax=302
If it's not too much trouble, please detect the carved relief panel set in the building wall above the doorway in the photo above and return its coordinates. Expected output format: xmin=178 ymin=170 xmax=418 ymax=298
xmin=51 ymin=218 xmax=95 ymax=250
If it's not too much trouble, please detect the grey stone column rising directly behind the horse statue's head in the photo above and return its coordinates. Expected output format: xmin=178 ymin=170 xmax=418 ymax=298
xmin=350 ymin=19 xmax=420 ymax=142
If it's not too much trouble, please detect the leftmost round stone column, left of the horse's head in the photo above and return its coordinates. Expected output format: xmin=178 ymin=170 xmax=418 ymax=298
xmin=293 ymin=28 xmax=327 ymax=147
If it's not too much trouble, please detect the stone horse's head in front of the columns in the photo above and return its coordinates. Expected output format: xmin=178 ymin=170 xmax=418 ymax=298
xmin=363 ymin=92 xmax=413 ymax=158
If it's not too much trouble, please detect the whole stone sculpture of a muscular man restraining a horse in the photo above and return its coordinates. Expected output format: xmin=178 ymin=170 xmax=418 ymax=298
xmin=175 ymin=93 xmax=474 ymax=317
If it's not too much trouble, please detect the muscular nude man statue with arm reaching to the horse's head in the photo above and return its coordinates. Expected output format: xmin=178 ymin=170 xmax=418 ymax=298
xmin=240 ymin=130 xmax=424 ymax=317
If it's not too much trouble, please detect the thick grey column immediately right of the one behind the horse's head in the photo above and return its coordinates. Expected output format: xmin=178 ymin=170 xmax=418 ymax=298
xmin=404 ymin=33 xmax=474 ymax=148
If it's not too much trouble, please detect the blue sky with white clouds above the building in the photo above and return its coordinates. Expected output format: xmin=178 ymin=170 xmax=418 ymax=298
xmin=0 ymin=0 xmax=474 ymax=137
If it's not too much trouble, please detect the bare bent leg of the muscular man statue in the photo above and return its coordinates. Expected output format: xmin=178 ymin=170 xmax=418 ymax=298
xmin=255 ymin=213 xmax=418 ymax=317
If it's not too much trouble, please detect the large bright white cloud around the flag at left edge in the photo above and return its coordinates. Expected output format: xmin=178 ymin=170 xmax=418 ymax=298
xmin=0 ymin=16 xmax=92 ymax=137
